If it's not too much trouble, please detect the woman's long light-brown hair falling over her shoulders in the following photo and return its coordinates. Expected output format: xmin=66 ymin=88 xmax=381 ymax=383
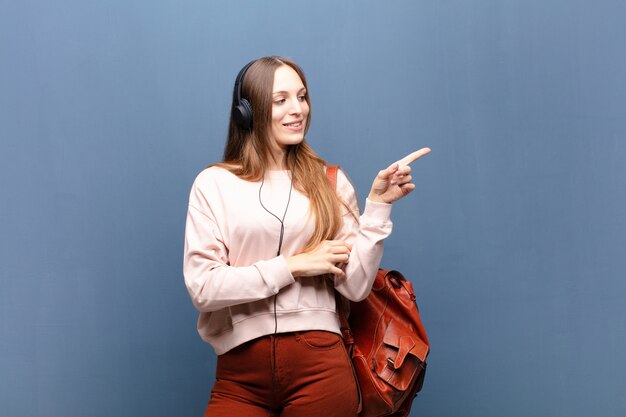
xmin=217 ymin=56 xmax=345 ymax=251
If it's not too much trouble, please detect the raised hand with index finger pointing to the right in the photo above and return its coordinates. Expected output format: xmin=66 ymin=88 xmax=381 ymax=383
xmin=367 ymin=148 xmax=430 ymax=204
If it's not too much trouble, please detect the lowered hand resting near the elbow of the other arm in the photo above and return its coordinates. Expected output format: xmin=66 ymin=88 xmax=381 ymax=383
xmin=287 ymin=240 xmax=352 ymax=278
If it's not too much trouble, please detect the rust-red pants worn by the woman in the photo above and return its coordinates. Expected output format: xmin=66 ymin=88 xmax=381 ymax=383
xmin=204 ymin=331 xmax=358 ymax=417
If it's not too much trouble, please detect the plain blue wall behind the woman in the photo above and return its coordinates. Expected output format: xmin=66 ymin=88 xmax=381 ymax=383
xmin=0 ymin=0 xmax=626 ymax=417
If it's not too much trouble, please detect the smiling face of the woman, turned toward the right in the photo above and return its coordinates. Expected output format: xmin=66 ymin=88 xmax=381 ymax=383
xmin=270 ymin=65 xmax=309 ymax=151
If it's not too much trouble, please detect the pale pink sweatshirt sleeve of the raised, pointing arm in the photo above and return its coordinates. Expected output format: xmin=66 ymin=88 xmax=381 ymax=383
xmin=335 ymin=170 xmax=392 ymax=301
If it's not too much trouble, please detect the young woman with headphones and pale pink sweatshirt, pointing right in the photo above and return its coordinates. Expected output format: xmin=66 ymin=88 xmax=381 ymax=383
xmin=184 ymin=57 xmax=430 ymax=417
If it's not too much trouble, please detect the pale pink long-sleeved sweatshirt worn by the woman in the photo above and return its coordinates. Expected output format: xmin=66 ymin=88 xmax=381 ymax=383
xmin=183 ymin=167 xmax=392 ymax=355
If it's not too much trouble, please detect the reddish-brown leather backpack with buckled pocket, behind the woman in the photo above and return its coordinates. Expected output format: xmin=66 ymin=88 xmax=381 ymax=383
xmin=327 ymin=166 xmax=430 ymax=417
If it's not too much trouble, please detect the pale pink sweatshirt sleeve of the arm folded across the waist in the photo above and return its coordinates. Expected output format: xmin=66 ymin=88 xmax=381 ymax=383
xmin=183 ymin=173 xmax=294 ymax=312
